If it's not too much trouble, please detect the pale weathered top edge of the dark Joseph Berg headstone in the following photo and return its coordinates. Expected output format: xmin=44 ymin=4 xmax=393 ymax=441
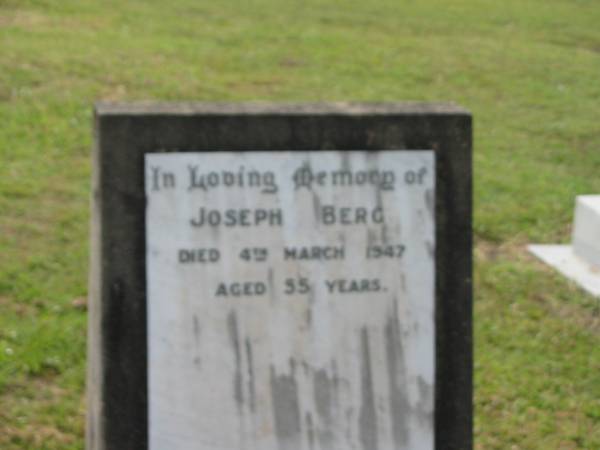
xmin=95 ymin=102 xmax=471 ymax=116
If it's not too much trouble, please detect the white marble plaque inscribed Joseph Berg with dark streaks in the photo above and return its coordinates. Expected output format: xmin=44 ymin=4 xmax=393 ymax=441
xmin=145 ymin=150 xmax=435 ymax=450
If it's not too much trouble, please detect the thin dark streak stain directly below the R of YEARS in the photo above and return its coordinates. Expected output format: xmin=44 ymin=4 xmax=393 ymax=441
xmin=358 ymin=327 xmax=379 ymax=450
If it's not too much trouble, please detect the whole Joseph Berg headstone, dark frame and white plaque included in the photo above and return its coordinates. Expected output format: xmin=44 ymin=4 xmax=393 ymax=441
xmin=87 ymin=104 xmax=472 ymax=450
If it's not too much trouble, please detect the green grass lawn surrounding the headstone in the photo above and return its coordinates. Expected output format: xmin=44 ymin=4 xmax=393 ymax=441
xmin=0 ymin=0 xmax=600 ymax=449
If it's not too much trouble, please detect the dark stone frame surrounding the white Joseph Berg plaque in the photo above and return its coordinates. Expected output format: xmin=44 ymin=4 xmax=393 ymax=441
xmin=86 ymin=103 xmax=473 ymax=450
